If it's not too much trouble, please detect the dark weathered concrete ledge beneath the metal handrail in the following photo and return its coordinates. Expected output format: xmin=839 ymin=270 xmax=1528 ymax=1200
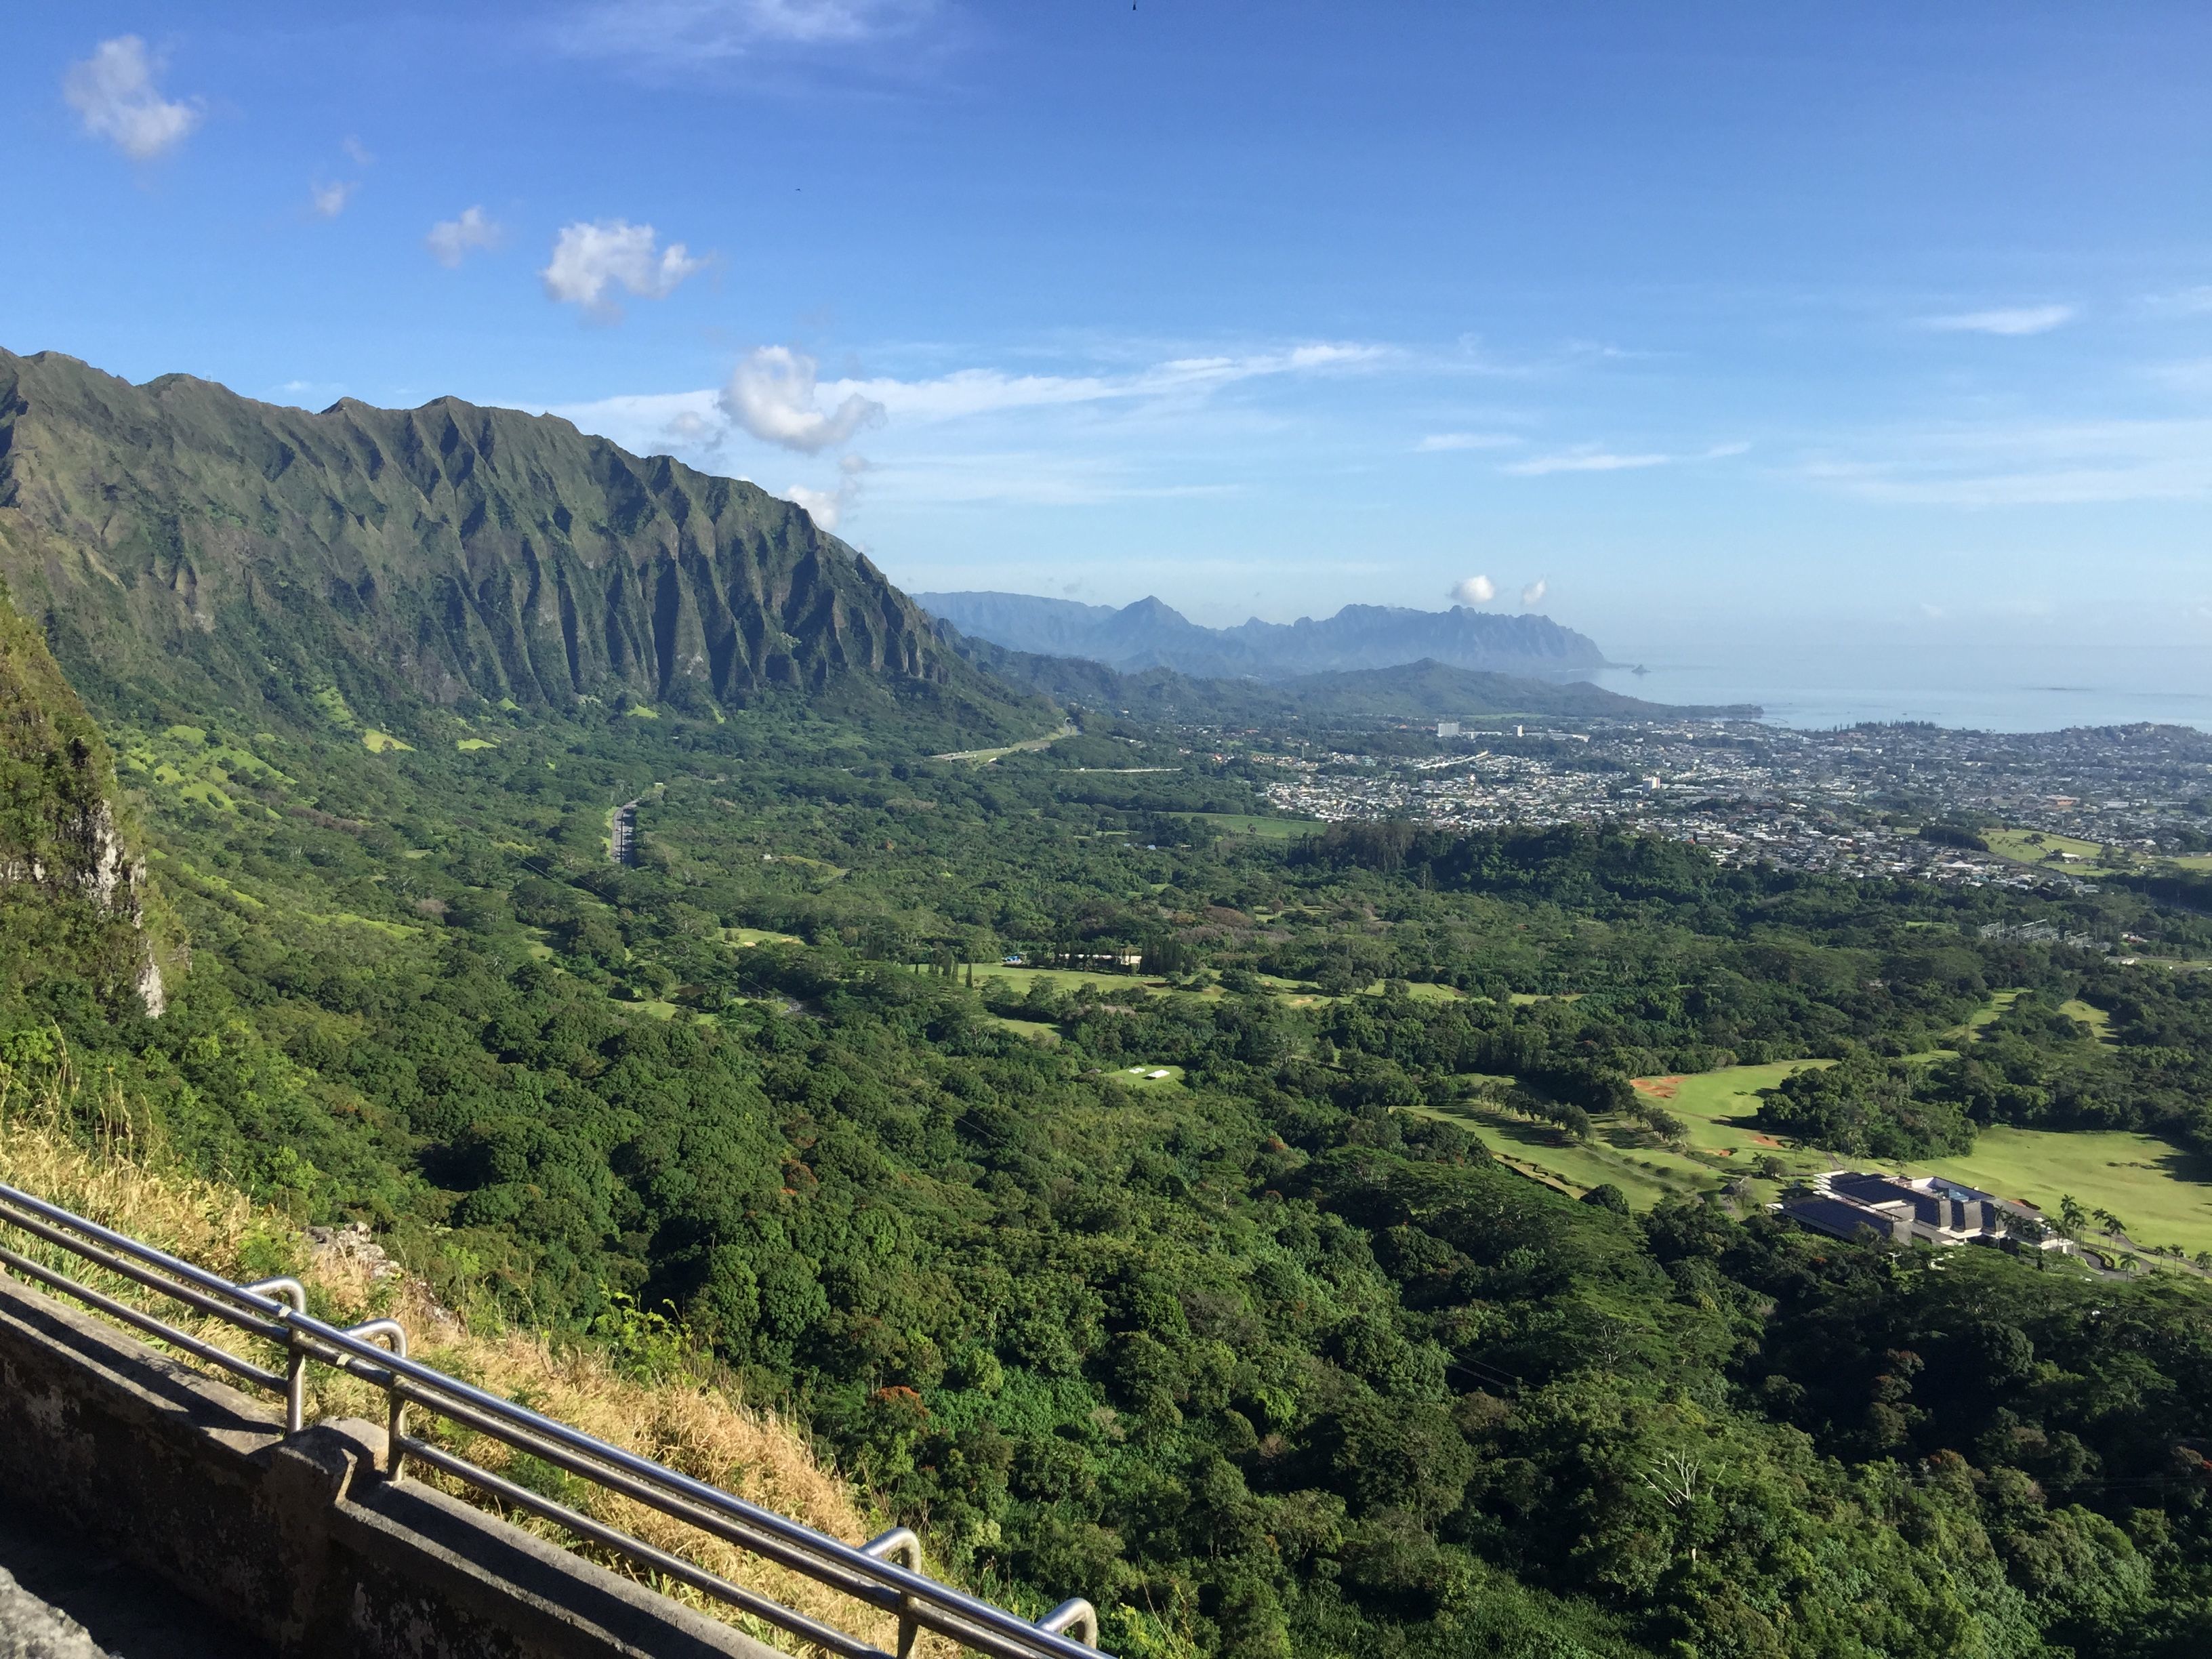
xmin=0 ymin=1276 xmax=774 ymax=1659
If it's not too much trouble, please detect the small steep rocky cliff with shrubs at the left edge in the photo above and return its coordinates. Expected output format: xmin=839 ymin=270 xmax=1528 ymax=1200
xmin=0 ymin=593 xmax=168 ymax=1015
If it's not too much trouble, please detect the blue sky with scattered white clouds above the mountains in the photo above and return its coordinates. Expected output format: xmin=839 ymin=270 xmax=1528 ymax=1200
xmin=0 ymin=0 xmax=2212 ymax=688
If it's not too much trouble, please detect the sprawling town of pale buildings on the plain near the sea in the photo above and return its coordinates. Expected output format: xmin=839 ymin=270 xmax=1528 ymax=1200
xmin=1248 ymin=721 xmax=2212 ymax=889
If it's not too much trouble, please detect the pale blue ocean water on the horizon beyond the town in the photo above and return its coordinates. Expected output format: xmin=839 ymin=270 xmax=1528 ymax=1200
xmin=1597 ymin=661 xmax=2212 ymax=732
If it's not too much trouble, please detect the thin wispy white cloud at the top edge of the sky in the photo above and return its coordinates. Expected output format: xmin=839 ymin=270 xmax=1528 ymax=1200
xmin=555 ymin=0 xmax=936 ymax=66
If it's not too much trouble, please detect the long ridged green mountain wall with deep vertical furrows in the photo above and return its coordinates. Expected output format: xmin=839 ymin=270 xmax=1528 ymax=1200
xmin=0 ymin=352 xmax=1004 ymax=708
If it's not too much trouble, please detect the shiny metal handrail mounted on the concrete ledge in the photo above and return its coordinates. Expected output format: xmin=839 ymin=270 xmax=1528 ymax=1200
xmin=0 ymin=1183 xmax=1099 ymax=1659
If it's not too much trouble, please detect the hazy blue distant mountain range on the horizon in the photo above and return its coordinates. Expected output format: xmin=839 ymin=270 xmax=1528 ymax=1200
xmin=914 ymin=593 xmax=1606 ymax=679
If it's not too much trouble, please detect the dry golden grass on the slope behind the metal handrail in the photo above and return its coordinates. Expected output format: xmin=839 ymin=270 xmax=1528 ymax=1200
xmin=0 ymin=1062 xmax=954 ymax=1659
